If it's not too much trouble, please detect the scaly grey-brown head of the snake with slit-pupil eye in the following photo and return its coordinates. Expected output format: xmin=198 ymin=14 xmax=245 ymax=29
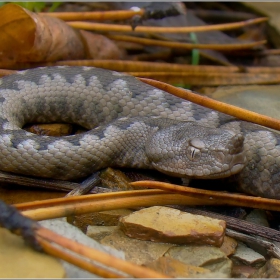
xmin=145 ymin=122 xmax=245 ymax=179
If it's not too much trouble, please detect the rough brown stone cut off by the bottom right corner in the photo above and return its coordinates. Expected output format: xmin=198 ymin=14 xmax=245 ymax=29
xmin=249 ymin=258 xmax=280 ymax=279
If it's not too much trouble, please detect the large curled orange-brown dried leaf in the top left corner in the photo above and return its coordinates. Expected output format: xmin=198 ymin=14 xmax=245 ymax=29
xmin=0 ymin=3 xmax=85 ymax=62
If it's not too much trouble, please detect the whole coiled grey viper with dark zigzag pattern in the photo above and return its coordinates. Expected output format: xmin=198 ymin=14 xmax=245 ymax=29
xmin=0 ymin=66 xmax=280 ymax=199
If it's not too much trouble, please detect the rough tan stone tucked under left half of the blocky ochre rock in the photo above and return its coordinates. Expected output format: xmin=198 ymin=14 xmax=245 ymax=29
xmin=100 ymin=229 xmax=173 ymax=265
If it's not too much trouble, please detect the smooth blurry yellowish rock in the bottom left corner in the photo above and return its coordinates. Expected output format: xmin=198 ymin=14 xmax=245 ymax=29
xmin=0 ymin=228 xmax=66 ymax=278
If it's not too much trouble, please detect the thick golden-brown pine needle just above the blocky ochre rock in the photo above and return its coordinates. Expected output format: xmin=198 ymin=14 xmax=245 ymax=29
xmin=18 ymin=190 xmax=210 ymax=221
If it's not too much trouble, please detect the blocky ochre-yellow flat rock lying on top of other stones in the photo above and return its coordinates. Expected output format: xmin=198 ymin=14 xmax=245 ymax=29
xmin=119 ymin=206 xmax=226 ymax=246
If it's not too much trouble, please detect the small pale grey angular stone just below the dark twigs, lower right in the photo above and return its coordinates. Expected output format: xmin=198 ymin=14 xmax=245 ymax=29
xmin=231 ymin=242 xmax=265 ymax=267
